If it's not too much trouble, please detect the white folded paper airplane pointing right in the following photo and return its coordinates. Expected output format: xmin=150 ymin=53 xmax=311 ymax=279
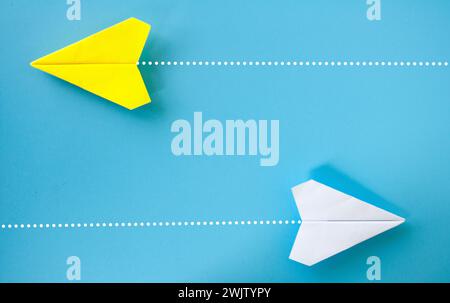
xmin=289 ymin=180 xmax=405 ymax=266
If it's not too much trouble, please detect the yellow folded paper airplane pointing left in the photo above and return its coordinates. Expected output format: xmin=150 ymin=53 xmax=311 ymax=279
xmin=31 ymin=18 xmax=151 ymax=109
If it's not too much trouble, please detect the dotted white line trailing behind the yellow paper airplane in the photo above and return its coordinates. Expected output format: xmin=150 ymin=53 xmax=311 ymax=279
xmin=136 ymin=60 xmax=448 ymax=67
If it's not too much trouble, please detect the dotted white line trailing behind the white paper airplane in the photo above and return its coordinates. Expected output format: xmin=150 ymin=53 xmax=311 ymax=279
xmin=1 ymin=220 xmax=301 ymax=230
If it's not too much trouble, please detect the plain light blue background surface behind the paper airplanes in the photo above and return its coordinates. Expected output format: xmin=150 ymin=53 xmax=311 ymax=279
xmin=0 ymin=0 xmax=450 ymax=282
